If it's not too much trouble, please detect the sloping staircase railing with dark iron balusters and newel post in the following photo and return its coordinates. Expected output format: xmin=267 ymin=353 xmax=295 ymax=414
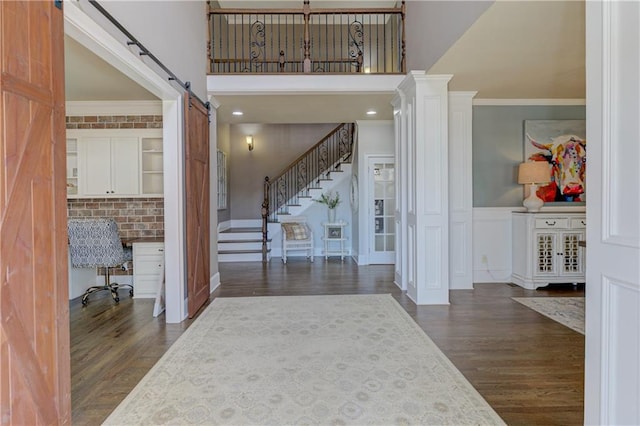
xmin=261 ymin=123 xmax=355 ymax=260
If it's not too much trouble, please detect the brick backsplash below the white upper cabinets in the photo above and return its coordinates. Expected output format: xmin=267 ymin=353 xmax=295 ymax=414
xmin=67 ymin=198 xmax=164 ymax=240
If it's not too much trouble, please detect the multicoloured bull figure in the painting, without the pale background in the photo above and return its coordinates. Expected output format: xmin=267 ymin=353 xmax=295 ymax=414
xmin=527 ymin=134 xmax=587 ymax=202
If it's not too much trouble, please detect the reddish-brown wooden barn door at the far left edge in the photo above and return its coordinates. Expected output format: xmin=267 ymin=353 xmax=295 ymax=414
xmin=0 ymin=1 xmax=71 ymax=425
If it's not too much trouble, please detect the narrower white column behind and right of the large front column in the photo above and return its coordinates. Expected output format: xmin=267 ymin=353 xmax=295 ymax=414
xmin=449 ymin=92 xmax=477 ymax=289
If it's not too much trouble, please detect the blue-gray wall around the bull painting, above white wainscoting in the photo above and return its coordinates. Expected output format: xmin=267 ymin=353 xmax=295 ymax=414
xmin=473 ymin=105 xmax=585 ymax=207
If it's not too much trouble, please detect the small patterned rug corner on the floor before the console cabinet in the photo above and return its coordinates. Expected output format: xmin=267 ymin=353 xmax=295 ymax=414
xmin=512 ymin=297 xmax=584 ymax=334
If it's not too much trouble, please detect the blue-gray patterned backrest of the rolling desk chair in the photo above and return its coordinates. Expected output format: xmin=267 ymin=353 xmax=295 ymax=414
xmin=67 ymin=218 xmax=126 ymax=268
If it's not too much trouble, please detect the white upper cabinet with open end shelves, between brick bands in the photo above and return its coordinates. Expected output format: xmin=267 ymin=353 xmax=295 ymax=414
xmin=67 ymin=129 xmax=162 ymax=198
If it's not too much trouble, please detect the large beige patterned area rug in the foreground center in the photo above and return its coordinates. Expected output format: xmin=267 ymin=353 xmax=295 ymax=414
xmin=105 ymin=295 xmax=504 ymax=425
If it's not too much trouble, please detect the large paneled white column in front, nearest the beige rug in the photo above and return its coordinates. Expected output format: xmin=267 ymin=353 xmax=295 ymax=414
xmin=398 ymin=71 xmax=451 ymax=305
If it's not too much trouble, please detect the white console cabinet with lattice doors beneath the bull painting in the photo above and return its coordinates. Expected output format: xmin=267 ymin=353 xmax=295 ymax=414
xmin=511 ymin=212 xmax=587 ymax=289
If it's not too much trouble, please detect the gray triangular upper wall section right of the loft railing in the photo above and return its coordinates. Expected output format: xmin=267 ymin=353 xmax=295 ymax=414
xmin=405 ymin=0 xmax=494 ymax=71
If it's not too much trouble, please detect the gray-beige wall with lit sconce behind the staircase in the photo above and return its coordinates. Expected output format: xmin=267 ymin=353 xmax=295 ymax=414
xmin=227 ymin=124 xmax=338 ymax=219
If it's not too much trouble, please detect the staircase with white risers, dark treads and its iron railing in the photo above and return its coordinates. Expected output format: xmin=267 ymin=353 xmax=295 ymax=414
xmin=218 ymin=123 xmax=355 ymax=262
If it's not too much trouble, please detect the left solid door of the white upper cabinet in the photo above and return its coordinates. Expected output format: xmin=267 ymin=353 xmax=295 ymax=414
xmin=78 ymin=138 xmax=112 ymax=196
